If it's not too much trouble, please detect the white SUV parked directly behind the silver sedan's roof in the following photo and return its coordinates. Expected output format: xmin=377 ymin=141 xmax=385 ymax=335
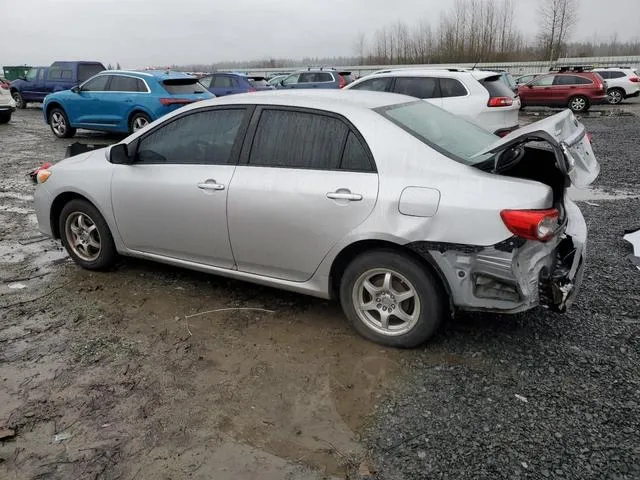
xmin=346 ymin=68 xmax=520 ymax=136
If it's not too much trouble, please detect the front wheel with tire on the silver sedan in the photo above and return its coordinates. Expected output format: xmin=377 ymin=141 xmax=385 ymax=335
xmin=58 ymin=199 xmax=118 ymax=270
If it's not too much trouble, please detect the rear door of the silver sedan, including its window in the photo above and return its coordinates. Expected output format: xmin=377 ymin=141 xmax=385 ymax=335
xmin=228 ymin=107 xmax=378 ymax=282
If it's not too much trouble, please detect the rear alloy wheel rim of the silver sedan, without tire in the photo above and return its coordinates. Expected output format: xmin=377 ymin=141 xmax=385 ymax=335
xmin=353 ymin=268 xmax=421 ymax=336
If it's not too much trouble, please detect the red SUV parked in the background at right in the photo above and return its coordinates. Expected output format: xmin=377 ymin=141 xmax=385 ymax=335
xmin=518 ymin=72 xmax=607 ymax=112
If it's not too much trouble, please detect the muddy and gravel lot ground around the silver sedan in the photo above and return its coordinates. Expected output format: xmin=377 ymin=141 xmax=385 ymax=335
xmin=0 ymin=105 xmax=640 ymax=479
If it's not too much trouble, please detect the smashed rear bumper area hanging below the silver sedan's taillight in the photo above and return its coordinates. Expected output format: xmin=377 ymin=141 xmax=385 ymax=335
xmin=410 ymin=200 xmax=587 ymax=313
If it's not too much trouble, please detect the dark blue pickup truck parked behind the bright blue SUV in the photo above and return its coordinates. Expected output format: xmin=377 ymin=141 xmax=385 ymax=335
xmin=10 ymin=62 xmax=105 ymax=108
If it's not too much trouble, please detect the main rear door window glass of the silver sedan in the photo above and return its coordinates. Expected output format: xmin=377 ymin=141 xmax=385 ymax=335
xmin=249 ymin=110 xmax=348 ymax=170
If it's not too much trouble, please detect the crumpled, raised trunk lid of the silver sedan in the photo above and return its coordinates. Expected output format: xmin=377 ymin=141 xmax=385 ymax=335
xmin=475 ymin=110 xmax=600 ymax=187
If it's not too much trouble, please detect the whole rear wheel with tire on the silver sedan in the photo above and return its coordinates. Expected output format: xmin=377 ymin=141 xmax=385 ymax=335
xmin=340 ymin=250 xmax=446 ymax=348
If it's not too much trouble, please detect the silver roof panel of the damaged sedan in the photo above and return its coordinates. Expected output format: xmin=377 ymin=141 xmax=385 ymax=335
xmin=180 ymin=89 xmax=412 ymax=114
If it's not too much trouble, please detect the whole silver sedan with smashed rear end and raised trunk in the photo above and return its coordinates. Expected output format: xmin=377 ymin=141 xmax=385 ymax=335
xmin=35 ymin=90 xmax=599 ymax=347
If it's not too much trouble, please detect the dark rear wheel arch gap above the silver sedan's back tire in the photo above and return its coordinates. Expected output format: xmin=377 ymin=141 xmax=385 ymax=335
xmin=329 ymin=240 xmax=454 ymax=313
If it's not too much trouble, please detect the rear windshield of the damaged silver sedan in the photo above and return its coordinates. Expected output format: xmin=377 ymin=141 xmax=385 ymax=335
xmin=375 ymin=100 xmax=498 ymax=165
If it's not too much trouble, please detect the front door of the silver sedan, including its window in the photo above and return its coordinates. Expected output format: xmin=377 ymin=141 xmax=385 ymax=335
xmin=111 ymin=107 xmax=247 ymax=268
